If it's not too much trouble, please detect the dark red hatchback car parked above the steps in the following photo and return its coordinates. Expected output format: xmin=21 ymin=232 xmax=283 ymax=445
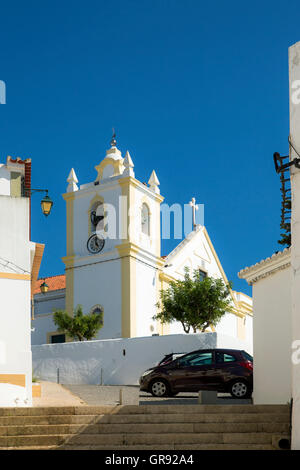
xmin=140 ymin=349 xmax=253 ymax=398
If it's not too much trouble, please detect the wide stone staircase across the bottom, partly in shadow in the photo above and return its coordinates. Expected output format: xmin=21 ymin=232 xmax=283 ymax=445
xmin=0 ymin=405 xmax=290 ymax=450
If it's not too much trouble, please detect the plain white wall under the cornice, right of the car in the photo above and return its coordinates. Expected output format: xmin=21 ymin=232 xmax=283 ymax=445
xmin=253 ymin=267 xmax=292 ymax=404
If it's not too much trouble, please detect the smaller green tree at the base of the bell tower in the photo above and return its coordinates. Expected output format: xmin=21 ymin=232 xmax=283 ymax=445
xmin=53 ymin=305 xmax=103 ymax=341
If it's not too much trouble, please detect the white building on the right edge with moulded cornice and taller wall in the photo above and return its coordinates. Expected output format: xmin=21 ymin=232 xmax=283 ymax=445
xmin=239 ymin=42 xmax=300 ymax=450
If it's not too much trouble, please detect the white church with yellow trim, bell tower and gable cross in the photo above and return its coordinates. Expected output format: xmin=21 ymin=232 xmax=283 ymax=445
xmin=32 ymin=135 xmax=252 ymax=345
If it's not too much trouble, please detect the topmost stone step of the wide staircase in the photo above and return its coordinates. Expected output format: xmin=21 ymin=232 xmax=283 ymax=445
xmin=0 ymin=405 xmax=289 ymax=417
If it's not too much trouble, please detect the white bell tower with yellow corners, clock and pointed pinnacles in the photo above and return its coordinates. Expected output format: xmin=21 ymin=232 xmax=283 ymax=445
xmin=63 ymin=134 xmax=164 ymax=339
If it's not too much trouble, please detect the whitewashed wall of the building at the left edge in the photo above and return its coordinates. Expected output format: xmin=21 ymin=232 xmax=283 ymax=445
xmin=0 ymin=195 xmax=35 ymax=406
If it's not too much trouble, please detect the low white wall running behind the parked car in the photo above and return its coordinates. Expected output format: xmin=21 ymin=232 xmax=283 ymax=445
xmin=32 ymin=333 xmax=251 ymax=385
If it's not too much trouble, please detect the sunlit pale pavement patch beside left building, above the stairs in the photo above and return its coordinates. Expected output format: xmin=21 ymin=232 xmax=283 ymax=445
xmin=33 ymin=381 xmax=87 ymax=406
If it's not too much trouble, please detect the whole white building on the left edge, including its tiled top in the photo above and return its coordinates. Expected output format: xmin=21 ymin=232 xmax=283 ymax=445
xmin=0 ymin=157 xmax=44 ymax=406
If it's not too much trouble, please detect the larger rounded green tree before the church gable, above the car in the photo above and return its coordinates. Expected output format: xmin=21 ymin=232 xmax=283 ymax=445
xmin=153 ymin=268 xmax=232 ymax=333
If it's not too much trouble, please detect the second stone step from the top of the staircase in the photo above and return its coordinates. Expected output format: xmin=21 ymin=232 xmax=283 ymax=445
xmin=0 ymin=412 xmax=290 ymax=429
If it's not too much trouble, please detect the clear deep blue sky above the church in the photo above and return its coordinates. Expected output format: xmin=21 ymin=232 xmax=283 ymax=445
xmin=0 ymin=0 xmax=300 ymax=293
